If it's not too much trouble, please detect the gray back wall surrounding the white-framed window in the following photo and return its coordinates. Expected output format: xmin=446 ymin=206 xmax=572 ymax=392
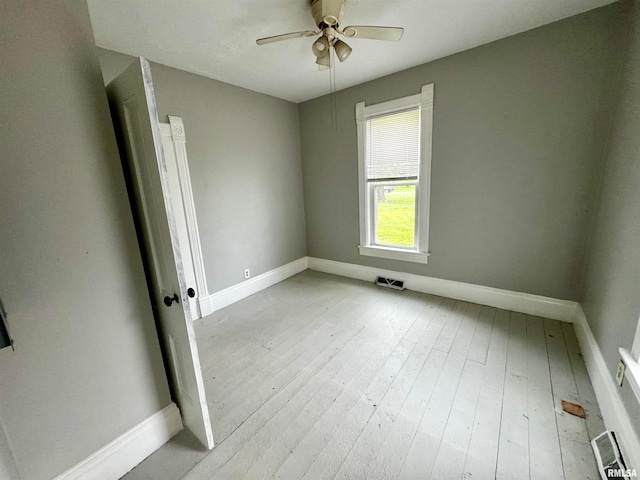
xmin=299 ymin=4 xmax=621 ymax=300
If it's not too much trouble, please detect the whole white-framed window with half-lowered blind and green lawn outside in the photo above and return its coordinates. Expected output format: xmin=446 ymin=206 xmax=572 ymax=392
xmin=356 ymin=84 xmax=433 ymax=263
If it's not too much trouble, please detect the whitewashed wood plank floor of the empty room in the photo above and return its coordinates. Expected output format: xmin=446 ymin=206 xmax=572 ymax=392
xmin=124 ymin=270 xmax=604 ymax=480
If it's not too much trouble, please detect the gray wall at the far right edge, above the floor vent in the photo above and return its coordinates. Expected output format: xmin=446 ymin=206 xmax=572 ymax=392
xmin=581 ymin=2 xmax=640 ymax=432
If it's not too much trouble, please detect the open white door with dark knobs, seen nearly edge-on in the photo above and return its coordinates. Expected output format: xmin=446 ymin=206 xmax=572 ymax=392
xmin=107 ymin=58 xmax=213 ymax=449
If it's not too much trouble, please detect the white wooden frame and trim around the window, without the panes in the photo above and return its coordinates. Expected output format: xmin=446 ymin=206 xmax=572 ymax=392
xmin=356 ymin=83 xmax=434 ymax=263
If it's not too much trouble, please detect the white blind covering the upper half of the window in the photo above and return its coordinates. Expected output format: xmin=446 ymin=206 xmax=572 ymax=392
xmin=366 ymin=108 xmax=420 ymax=181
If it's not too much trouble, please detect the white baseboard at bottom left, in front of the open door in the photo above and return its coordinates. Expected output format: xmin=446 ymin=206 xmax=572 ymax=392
xmin=55 ymin=403 xmax=182 ymax=480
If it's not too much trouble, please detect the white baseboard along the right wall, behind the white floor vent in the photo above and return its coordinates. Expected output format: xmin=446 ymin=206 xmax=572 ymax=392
xmin=573 ymin=305 xmax=640 ymax=469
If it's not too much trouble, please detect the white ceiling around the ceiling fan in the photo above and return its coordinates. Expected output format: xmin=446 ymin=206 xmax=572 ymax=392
xmin=88 ymin=0 xmax=614 ymax=102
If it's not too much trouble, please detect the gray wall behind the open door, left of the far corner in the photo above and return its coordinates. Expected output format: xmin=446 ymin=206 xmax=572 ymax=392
xmin=99 ymin=49 xmax=306 ymax=293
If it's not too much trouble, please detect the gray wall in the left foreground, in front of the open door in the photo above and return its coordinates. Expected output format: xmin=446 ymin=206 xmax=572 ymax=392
xmin=0 ymin=0 xmax=170 ymax=480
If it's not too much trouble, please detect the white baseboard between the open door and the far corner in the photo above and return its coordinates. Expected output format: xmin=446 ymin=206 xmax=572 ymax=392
xmin=200 ymin=257 xmax=307 ymax=317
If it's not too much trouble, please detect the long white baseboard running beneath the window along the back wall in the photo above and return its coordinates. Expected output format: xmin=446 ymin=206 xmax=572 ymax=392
xmin=308 ymin=257 xmax=577 ymax=322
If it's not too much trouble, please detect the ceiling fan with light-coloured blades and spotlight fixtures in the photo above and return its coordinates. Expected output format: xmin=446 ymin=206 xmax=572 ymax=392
xmin=256 ymin=0 xmax=404 ymax=70
